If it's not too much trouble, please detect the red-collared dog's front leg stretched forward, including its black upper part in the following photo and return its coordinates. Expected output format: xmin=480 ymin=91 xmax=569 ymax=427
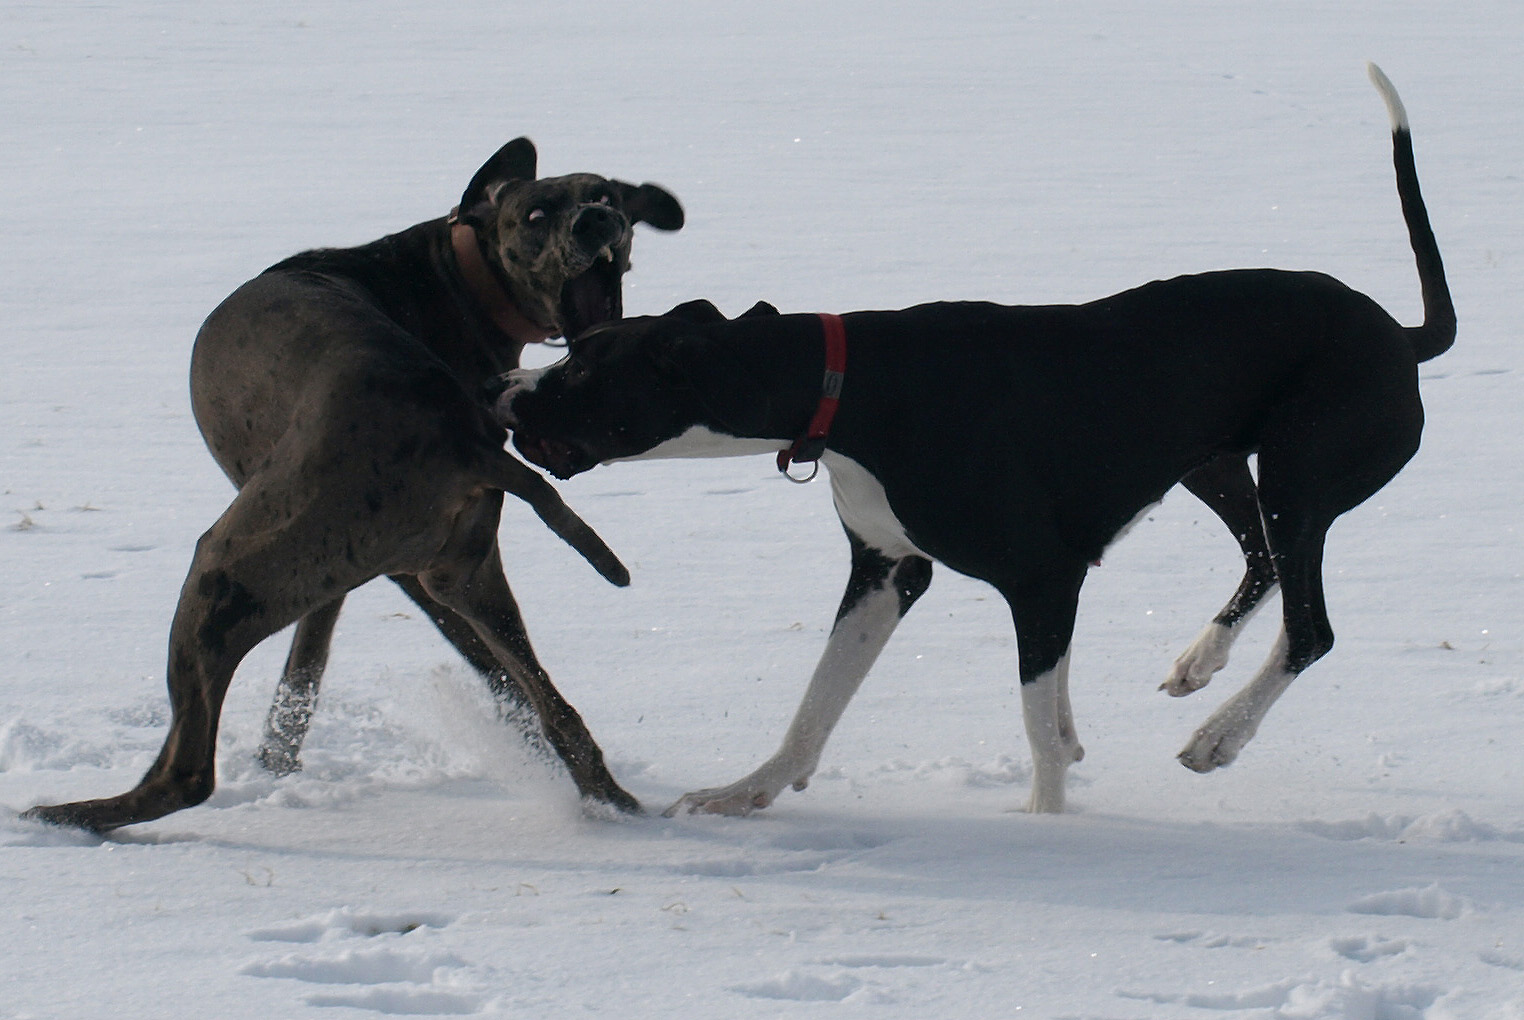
xmin=664 ymin=529 xmax=931 ymax=817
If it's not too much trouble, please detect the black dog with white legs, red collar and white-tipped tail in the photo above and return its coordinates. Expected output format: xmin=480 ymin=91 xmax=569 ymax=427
xmin=497 ymin=67 xmax=1455 ymax=814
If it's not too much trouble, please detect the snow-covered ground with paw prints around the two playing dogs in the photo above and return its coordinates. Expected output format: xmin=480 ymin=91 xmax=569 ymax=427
xmin=0 ymin=0 xmax=1524 ymax=1020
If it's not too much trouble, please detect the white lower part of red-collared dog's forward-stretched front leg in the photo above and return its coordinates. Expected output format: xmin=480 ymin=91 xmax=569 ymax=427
xmin=664 ymin=579 xmax=899 ymax=817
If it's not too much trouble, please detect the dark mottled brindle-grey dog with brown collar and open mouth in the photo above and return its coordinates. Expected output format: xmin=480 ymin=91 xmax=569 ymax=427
xmin=26 ymin=139 xmax=683 ymax=831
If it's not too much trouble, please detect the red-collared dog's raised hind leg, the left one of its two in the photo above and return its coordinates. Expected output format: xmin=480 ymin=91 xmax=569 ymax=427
xmin=1160 ymin=454 xmax=1276 ymax=698
